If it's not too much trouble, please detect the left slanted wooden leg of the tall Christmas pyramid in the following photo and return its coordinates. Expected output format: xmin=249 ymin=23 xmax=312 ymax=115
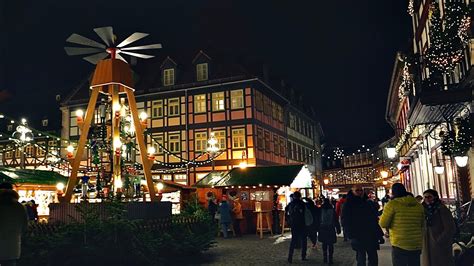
xmin=60 ymin=87 xmax=100 ymax=202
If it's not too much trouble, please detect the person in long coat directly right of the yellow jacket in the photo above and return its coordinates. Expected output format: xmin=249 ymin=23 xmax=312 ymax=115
xmin=421 ymin=189 xmax=456 ymax=266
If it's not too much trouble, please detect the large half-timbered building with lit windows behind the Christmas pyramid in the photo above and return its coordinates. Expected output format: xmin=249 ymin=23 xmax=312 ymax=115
xmin=61 ymin=51 xmax=322 ymax=185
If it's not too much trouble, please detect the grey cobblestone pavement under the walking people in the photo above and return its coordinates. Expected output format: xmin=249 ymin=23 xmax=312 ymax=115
xmin=202 ymin=233 xmax=391 ymax=266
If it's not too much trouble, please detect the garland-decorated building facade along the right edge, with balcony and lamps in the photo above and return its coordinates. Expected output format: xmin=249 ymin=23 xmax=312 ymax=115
xmin=386 ymin=0 xmax=474 ymax=202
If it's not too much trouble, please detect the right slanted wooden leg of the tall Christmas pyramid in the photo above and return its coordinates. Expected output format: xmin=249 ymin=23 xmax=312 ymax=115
xmin=126 ymin=89 xmax=159 ymax=201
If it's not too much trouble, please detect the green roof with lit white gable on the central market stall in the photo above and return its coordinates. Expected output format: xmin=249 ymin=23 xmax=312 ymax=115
xmin=194 ymin=165 xmax=311 ymax=188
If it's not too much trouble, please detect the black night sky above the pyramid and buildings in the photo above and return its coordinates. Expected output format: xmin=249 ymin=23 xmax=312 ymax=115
xmin=0 ymin=0 xmax=411 ymax=146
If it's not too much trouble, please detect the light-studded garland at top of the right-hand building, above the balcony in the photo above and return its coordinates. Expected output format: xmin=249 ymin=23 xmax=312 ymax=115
xmin=426 ymin=1 xmax=470 ymax=74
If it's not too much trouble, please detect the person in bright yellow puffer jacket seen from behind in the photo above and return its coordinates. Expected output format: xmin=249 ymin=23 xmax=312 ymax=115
xmin=380 ymin=183 xmax=424 ymax=266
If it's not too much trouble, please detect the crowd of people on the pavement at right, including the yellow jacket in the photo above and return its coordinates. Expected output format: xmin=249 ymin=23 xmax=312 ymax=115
xmin=285 ymin=183 xmax=456 ymax=266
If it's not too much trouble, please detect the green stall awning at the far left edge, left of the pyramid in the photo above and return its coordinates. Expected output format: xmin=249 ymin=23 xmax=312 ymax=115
xmin=0 ymin=167 xmax=68 ymax=186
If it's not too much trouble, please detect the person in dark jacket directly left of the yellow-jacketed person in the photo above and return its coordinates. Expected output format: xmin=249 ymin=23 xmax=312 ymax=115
xmin=341 ymin=185 xmax=385 ymax=266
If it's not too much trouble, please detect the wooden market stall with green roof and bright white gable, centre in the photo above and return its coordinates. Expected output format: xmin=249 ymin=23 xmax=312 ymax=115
xmin=194 ymin=165 xmax=312 ymax=233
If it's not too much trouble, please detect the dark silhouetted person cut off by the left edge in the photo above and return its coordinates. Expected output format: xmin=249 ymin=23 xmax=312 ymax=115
xmin=0 ymin=183 xmax=28 ymax=266
